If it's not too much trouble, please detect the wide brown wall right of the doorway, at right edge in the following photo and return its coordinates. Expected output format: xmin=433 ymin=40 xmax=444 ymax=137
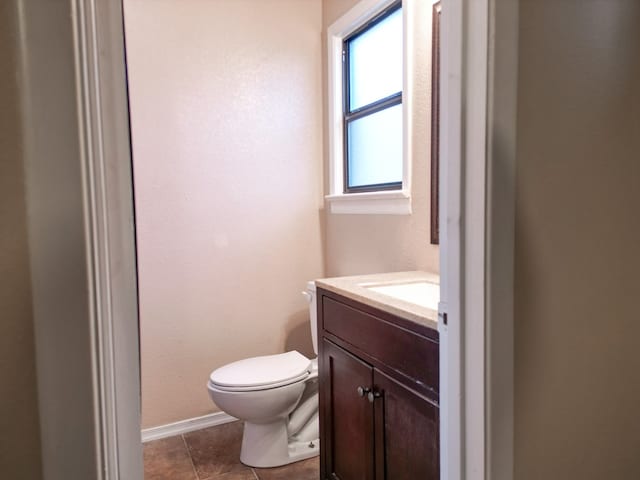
xmin=515 ymin=0 xmax=640 ymax=480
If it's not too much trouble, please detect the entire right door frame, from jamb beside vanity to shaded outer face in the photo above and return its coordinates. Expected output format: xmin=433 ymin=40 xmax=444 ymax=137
xmin=440 ymin=0 xmax=518 ymax=480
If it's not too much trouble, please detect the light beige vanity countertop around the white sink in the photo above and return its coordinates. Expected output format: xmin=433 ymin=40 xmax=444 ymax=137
xmin=315 ymin=271 xmax=440 ymax=330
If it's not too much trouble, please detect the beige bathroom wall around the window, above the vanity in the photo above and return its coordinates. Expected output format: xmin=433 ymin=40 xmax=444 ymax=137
xmin=322 ymin=0 xmax=439 ymax=276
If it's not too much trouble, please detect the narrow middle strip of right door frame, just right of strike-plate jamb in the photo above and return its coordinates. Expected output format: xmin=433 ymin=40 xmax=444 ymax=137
xmin=462 ymin=0 xmax=490 ymax=480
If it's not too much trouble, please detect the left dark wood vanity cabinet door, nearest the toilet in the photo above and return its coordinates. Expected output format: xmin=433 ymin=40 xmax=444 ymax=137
xmin=322 ymin=340 xmax=374 ymax=480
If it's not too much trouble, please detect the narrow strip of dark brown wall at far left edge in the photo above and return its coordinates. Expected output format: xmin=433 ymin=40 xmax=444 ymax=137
xmin=0 ymin=1 xmax=41 ymax=480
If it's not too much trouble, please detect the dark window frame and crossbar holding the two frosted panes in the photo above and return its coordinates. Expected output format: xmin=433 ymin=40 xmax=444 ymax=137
xmin=342 ymin=0 xmax=404 ymax=194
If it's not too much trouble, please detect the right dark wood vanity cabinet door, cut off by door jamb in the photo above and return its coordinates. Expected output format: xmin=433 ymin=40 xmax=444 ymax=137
xmin=373 ymin=370 xmax=440 ymax=480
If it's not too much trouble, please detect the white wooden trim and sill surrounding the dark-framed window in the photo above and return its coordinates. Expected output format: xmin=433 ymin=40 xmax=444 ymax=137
xmin=325 ymin=0 xmax=413 ymax=215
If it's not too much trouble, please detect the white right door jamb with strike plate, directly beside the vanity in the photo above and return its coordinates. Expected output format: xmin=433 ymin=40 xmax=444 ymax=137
xmin=438 ymin=0 xmax=465 ymax=480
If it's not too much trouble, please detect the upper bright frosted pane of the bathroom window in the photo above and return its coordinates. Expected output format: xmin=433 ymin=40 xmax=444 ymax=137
xmin=349 ymin=9 xmax=402 ymax=111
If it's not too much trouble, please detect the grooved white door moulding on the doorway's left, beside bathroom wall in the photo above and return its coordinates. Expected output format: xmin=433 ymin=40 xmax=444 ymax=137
xmin=73 ymin=0 xmax=142 ymax=480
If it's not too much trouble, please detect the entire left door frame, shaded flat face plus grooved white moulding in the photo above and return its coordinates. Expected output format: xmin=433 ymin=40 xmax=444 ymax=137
xmin=21 ymin=0 xmax=143 ymax=480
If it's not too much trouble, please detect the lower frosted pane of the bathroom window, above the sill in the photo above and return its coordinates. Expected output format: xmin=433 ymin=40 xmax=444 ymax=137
xmin=347 ymin=104 xmax=402 ymax=188
